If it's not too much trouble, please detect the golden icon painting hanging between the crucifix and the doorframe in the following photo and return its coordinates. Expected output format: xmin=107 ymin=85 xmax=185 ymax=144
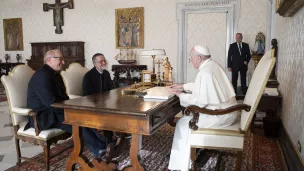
xmin=115 ymin=7 xmax=144 ymax=49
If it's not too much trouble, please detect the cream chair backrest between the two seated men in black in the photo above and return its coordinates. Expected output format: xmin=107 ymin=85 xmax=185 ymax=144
xmin=61 ymin=63 xmax=88 ymax=96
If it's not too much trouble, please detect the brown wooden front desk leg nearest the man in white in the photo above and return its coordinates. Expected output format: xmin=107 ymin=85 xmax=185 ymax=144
xmin=124 ymin=134 xmax=144 ymax=171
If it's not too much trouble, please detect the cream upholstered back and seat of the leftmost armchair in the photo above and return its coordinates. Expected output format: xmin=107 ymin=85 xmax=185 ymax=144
xmin=1 ymin=65 xmax=64 ymax=140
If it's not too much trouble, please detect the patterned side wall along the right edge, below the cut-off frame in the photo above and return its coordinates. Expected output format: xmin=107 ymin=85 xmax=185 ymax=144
xmin=276 ymin=7 xmax=304 ymax=145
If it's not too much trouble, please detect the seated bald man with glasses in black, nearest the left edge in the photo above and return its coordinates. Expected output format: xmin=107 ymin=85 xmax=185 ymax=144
xmin=27 ymin=50 xmax=112 ymax=157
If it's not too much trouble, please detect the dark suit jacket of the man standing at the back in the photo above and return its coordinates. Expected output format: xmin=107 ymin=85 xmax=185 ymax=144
xmin=228 ymin=42 xmax=251 ymax=69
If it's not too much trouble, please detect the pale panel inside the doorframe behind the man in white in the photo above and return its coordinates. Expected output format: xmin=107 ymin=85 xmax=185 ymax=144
xmin=187 ymin=13 xmax=227 ymax=82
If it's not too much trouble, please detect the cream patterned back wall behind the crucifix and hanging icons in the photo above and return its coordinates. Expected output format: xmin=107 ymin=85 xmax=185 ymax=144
xmin=0 ymin=0 xmax=267 ymax=82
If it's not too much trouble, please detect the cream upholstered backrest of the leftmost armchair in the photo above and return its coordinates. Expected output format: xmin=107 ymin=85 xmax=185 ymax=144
xmin=1 ymin=65 xmax=35 ymax=125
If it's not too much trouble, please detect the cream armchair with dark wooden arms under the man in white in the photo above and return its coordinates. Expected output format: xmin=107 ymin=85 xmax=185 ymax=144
xmin=184 ymin=51 xmax=276 ymax=170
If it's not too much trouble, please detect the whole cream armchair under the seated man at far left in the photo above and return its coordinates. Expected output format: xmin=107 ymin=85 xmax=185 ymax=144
xmin=1 ymin=65 xmax=71 ymax=170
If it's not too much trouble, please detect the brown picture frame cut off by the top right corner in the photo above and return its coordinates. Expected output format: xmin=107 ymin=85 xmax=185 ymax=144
xmin=276 ymin=0 xmax=304 ymax=17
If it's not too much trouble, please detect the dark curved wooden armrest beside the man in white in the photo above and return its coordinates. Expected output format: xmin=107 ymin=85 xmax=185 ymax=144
xmin=184 ymin=104 xmax=251 ymax=130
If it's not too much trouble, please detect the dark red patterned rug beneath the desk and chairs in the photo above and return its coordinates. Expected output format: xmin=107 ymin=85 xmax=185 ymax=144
xmin=8 ymin=124 xmax=286 ymax=171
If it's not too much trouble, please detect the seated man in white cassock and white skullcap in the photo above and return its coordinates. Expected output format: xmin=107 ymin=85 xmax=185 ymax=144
xmin=169 ymin=45 xmax=238 ymax=171
